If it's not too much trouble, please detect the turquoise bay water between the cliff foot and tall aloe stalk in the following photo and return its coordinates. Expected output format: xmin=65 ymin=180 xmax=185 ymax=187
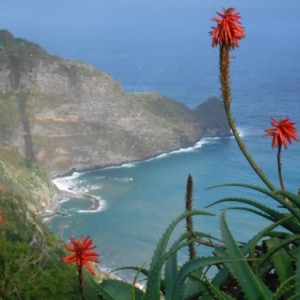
xmin=49 ymin=134 xmax=292 ymax=278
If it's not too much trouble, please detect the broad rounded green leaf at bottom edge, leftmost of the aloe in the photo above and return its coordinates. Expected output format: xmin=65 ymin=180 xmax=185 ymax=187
xmin=100 ymin=279 xmax=145 ymax=300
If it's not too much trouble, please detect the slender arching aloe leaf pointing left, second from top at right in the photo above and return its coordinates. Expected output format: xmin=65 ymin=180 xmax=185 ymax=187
xmin=206 ymin=197 xmax=300 ymax=233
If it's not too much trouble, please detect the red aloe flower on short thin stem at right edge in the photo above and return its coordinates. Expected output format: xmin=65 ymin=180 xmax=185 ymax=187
xmin=264 ymin=117 xmax=299 ymax=149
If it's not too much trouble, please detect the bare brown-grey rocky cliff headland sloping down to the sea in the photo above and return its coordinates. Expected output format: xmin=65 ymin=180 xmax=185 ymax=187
xmin=0 ymin=30 xmax=230 ymax=177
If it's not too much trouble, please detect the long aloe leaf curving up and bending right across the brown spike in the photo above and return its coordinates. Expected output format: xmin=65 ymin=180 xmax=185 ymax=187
xmin=146 ymin=210 xmax=214 ymax=300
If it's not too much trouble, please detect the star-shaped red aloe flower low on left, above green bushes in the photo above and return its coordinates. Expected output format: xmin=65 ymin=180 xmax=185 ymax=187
xmin=62 ymin=236 xmax=100 ymax=275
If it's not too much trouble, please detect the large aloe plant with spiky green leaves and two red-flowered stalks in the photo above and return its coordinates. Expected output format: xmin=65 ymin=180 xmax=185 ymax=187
xmin=99 ymin=8 xmax=300 ymax=300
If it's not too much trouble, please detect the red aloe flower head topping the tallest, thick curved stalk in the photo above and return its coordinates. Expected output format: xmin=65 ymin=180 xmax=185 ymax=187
xmin=209 ymin=8 xmax=245 ymax=49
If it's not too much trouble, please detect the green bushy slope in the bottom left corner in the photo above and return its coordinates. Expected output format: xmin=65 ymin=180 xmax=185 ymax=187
xmin=0 ymin=191 xmax=96 ymax=300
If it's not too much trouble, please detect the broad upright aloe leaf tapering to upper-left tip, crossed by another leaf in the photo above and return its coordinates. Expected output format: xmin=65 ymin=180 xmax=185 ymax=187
xmin=220 ymin=210 xmax=273 ymax=300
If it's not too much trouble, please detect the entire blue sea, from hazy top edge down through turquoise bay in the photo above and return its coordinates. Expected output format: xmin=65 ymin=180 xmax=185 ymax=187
xmin=0 ymin=0 xmax=300 ymax=282
